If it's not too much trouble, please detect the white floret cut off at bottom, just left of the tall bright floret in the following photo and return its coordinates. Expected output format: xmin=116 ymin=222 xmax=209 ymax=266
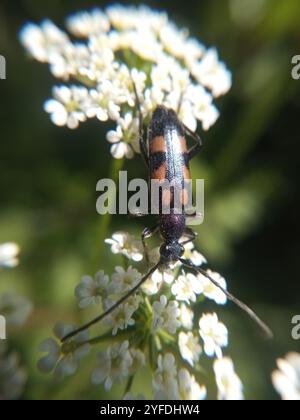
xmin=178 ymin=369 xmax=207 ymax=401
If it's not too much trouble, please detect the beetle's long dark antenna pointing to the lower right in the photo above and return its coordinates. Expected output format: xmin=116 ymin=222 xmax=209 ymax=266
xmin=179 ymin=258 xmax=273 ymax=339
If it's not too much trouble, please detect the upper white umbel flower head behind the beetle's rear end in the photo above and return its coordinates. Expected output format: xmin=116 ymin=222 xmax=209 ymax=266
xmin=20 ymin=5 xmax=231 ymax=159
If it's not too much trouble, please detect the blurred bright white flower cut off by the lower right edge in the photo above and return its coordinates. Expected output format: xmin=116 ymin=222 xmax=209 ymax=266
xmin=272 ymin=352 xmax=300 ymax=401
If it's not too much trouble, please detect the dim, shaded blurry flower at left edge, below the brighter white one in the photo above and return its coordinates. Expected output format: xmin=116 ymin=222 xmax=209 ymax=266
xmin=0 ymin=293 xmax=33 ymax=328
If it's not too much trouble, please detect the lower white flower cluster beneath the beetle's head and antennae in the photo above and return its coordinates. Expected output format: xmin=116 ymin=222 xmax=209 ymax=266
xmin=39 ymin=232 xmax=243 ymax=400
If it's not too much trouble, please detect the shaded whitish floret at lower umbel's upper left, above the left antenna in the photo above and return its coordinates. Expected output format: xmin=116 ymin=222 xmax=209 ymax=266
xmin=75 ymin=271 xmax=110 ymax=308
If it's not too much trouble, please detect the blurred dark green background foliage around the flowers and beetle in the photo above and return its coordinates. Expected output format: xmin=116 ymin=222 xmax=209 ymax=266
xmin=0 ymin=0 xmax=300 ymax=399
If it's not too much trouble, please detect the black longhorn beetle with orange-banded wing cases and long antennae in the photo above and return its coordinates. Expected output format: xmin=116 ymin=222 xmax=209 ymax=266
xmin=62 ymin=101 xmax=272 ymax=341
